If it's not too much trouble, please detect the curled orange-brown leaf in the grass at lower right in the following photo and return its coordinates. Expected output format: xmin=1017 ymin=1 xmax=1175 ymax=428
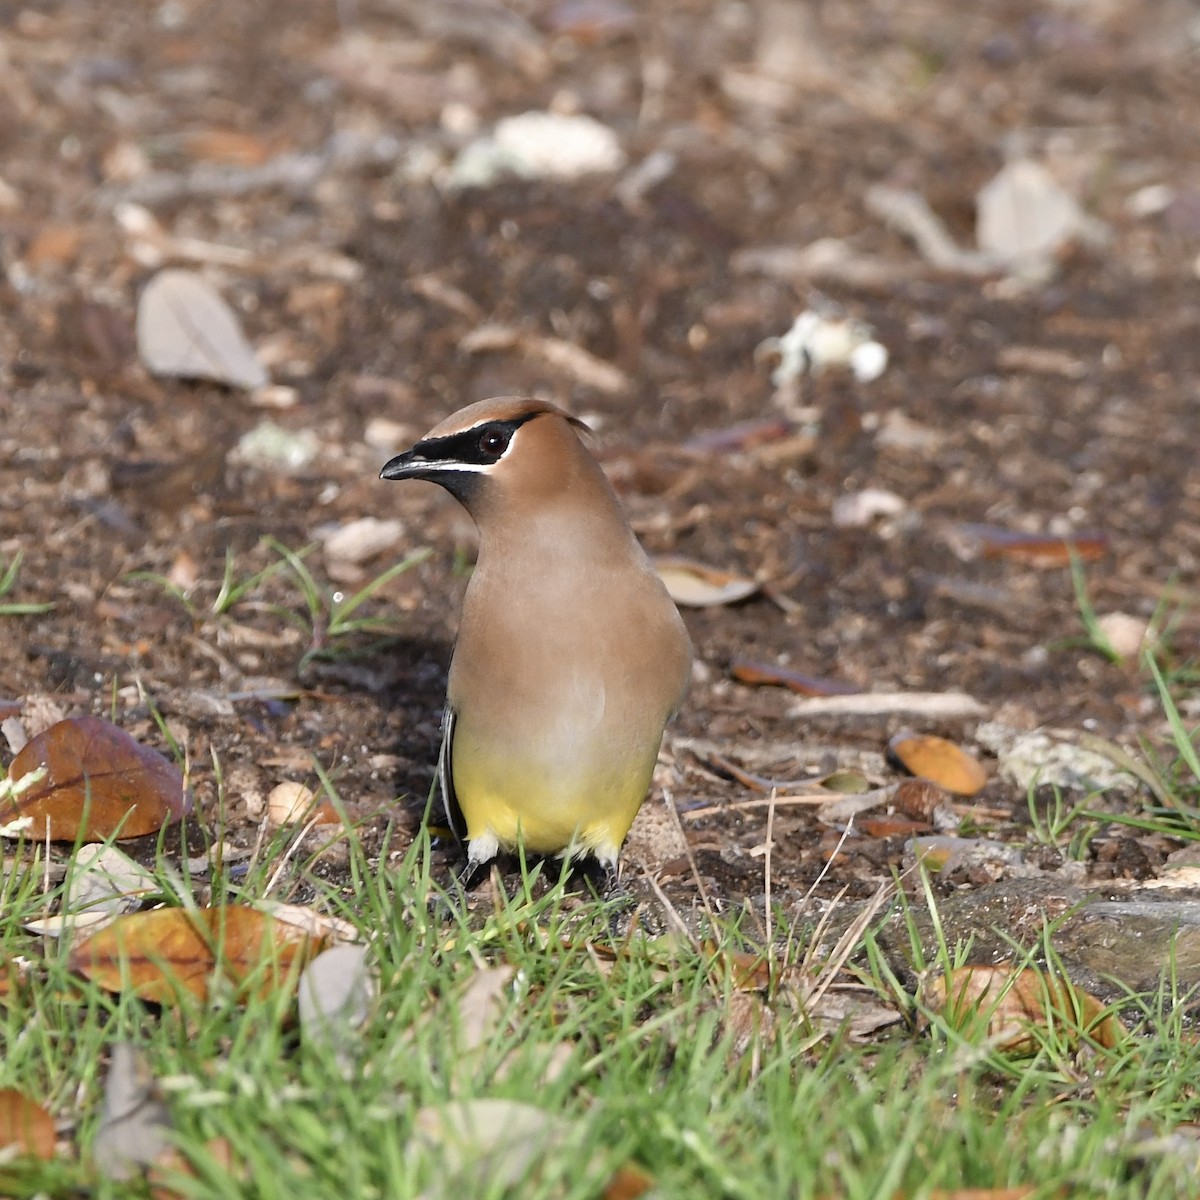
xmin=923 ymin=966 xmax=1124 ymax=1054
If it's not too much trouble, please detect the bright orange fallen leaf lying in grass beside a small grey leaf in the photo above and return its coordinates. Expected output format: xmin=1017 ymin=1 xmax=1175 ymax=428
xmin=71 ymin=905 xmax=325 ymax=1004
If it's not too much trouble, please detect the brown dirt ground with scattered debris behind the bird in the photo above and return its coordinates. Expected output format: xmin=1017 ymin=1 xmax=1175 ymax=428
xmin=0 ymin=0 xmax=1200 ymax=907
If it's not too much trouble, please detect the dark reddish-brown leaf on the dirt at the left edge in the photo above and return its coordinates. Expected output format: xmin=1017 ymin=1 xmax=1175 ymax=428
xmin=0 ymin=716 xmax=192 ymax=841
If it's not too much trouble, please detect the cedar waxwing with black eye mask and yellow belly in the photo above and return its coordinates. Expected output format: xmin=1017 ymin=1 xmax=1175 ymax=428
xmin=380 ymin=397 xmax=692 ymax=890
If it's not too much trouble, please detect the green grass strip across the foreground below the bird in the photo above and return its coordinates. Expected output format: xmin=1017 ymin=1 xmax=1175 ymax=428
xmin=0 ymin=801 xmax=1200 ymax=1200
